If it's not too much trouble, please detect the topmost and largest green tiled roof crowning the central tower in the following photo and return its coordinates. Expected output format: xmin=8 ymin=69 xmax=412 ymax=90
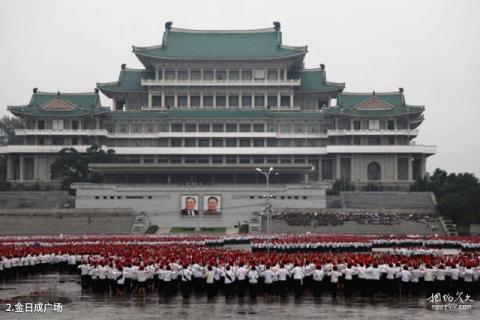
xmin=133 ymin=28 xmax=307 ymax=60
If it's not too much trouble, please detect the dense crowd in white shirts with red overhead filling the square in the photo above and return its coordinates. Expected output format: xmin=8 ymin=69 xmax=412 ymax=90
xmin=0 ymin=235 xmax=480 ymax=299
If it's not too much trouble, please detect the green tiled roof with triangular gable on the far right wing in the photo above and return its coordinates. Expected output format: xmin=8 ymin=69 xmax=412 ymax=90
xmin=326 ymin=91 xmax=424 ymax=116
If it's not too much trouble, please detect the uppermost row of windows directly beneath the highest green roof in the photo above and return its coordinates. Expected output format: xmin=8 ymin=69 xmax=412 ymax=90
xmin=158 ymin=69 xmax=285 ymax=81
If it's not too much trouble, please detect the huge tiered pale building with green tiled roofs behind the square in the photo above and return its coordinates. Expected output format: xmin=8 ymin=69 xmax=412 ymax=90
xmin=0 ymin=22 xmax=435 ymax=226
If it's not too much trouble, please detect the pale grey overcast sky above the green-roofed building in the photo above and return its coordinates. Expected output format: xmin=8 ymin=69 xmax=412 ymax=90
xmin=0 ymin=0 xmax=480 ymax=176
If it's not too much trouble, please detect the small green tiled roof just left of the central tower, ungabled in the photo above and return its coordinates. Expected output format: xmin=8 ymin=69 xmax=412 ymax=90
xmin=97 ymin=68 xmax=155 ymax=96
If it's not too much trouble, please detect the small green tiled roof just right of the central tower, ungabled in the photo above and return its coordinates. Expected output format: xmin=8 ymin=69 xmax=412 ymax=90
xmin=289 ymin=68 xmax=345 ymax=92
